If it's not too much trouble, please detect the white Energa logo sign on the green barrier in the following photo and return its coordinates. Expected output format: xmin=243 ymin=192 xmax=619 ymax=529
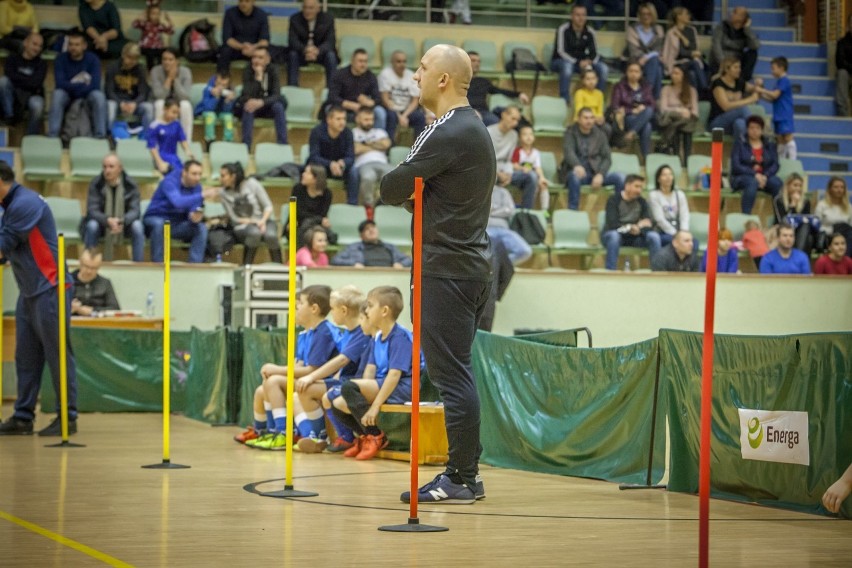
xmin=738 ymin=408 xmax=810 ymax=465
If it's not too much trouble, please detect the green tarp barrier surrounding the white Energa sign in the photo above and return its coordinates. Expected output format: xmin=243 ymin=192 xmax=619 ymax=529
xmin=659 ymin=330 xmax=852 ymax=517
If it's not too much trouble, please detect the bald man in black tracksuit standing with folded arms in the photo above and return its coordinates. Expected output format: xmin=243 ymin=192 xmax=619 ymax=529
xmin=381 ymin=45 xmax=497 ymax=504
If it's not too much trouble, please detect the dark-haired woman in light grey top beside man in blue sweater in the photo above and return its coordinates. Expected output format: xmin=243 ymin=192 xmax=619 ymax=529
xmin=219 ymin=162 xmax=281 ymax=264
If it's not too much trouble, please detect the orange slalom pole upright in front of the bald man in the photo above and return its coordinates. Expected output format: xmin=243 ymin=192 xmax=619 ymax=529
xmin=408 ymin=178 xmax=423 ymax=520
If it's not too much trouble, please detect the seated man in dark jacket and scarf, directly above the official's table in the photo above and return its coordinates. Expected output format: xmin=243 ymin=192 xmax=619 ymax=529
xmin=80 ymin=154 xmax=145 ymax=262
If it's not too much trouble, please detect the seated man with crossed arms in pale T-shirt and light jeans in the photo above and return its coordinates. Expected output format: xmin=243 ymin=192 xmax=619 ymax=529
xmin=346 ymin=107 xmax=395 ymax=211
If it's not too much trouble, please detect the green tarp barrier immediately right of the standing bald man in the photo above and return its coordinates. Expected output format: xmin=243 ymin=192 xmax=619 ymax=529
xmin=473 ymin=332 xmax=663 ymax=484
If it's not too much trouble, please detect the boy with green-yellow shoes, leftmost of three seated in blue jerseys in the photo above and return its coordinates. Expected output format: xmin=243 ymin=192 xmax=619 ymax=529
xmin=246 ymin=285 xmax=340 ymax=450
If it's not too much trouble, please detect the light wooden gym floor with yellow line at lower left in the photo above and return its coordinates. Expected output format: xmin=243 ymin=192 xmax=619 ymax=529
xmin=0 ymin=405 xmax=852 ymax=568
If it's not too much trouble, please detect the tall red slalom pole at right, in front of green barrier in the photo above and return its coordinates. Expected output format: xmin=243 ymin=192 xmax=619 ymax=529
xmin=698 ymin=128 xmax=724 ymax=568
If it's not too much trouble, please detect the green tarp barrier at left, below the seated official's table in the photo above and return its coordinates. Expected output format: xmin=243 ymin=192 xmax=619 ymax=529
xmin=41 ymin=327 xmax=190 ymax=413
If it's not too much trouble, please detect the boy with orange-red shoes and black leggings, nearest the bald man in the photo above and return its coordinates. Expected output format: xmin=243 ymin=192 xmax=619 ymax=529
xmin=332 ymin=286 xmax=420 ymax=460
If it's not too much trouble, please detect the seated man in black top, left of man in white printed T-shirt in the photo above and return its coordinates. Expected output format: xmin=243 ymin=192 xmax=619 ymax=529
xmin=326 ymin=48 xmax=387 ymax=130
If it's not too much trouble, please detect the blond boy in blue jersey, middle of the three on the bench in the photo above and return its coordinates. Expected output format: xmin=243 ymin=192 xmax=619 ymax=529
xmin=296 ymin=286 xmax=370 ymax=453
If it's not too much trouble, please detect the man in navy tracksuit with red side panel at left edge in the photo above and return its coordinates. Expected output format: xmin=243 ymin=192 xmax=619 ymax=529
xmin=0 ymin=160 xmax=77 ymax=436
